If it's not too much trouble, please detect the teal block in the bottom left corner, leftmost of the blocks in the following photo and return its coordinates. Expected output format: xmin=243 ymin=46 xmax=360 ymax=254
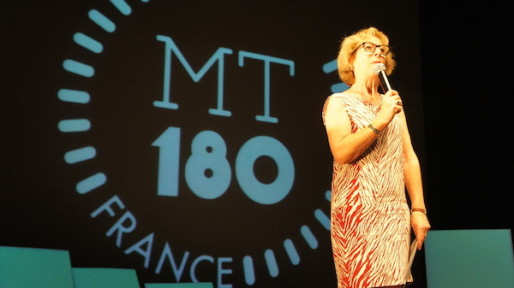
xmin=0 ymin=246 xmax=73 ymax=288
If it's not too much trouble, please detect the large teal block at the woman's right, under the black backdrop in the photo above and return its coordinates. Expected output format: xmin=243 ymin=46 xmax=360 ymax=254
xmin=424 ymin=229 xmax=514 ymax=288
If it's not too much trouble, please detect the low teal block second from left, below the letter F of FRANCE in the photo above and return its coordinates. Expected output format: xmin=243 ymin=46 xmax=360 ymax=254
xmin=71 ymin=268 xmax=140 ymax=288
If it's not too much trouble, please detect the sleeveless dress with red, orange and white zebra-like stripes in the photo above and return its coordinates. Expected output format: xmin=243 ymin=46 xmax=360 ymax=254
xmin=322 ymin=92 xmax=412 ymax=288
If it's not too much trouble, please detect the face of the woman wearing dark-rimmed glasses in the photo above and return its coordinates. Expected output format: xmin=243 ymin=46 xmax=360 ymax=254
xmin=353 ymin=37 xmax=388 ymax=79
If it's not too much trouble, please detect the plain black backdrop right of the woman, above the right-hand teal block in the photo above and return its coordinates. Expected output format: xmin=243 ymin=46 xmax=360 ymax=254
xmin=420 ymin=1 xmax=514 ymax=233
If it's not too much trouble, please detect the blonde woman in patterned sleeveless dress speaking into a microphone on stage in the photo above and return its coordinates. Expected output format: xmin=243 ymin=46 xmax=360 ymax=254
xmin=322 ymin=27 xmax=430 ymax=288
